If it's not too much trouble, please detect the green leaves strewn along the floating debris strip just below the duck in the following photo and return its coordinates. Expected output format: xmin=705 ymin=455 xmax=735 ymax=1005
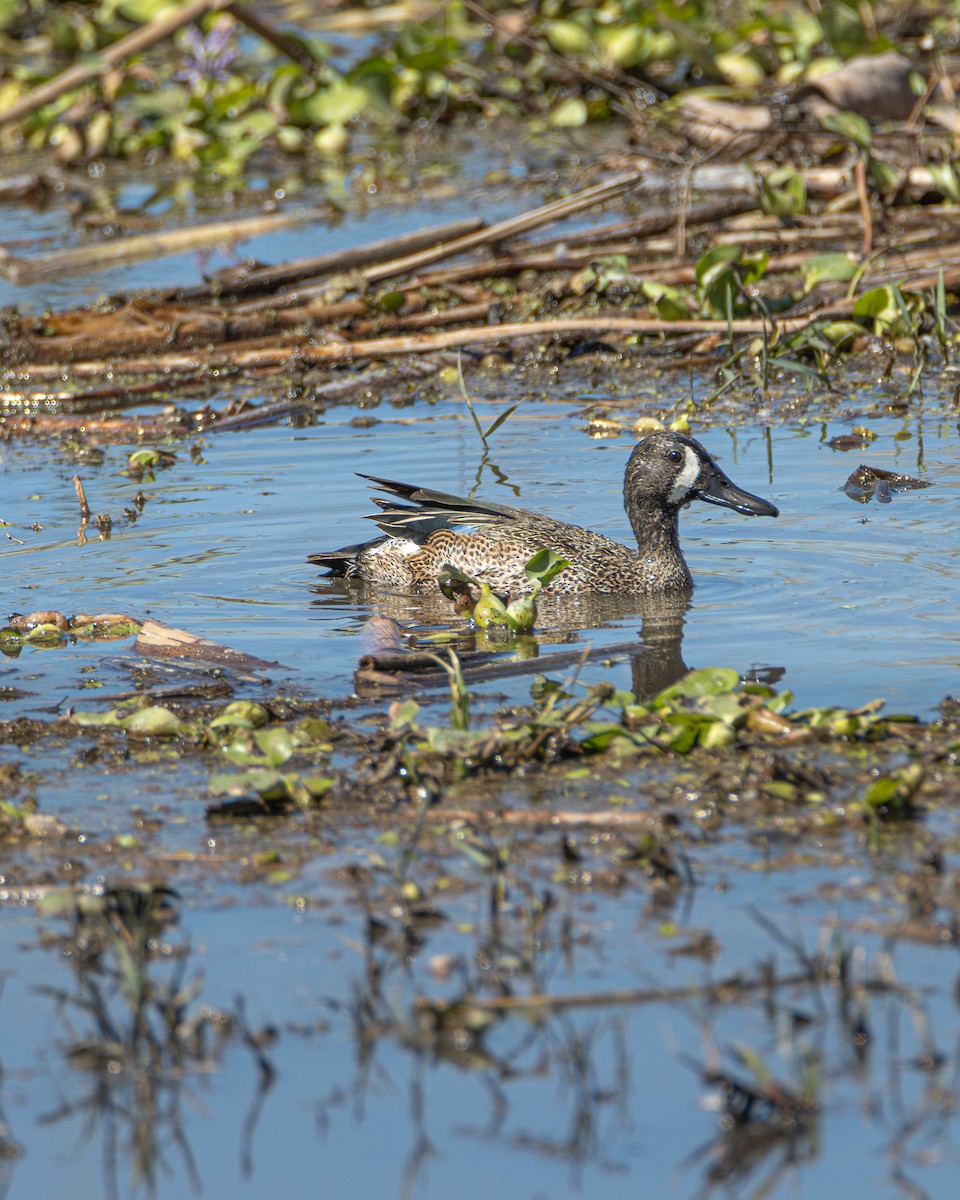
xmin=58 ymin=655 xmax=931 ymax=818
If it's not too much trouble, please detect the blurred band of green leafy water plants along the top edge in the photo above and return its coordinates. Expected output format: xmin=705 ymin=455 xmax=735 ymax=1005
xmin=0 ymin=0 xmax=945 ymax=174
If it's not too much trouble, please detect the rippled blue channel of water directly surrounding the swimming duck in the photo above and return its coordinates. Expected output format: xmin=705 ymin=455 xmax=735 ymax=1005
xmin=0 ymin=388 xmax=960 ymax=712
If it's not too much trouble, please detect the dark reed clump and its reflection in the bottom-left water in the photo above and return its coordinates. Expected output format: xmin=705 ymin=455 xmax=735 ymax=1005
xmin=40 ymin=886 xmax=274 ymax=1200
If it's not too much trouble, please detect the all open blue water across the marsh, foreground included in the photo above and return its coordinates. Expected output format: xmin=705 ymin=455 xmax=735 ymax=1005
xmin=0 ymin=159 xmax=960 ymax=1200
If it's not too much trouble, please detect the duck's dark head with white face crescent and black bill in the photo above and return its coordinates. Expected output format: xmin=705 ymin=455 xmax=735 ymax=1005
xmin=624 ymin=432 xmax=779 ymax=517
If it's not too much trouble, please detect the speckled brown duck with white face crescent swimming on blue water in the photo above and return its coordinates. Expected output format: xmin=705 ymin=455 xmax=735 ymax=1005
xmin=310 ymin=433 xmax=778 ymax=595
